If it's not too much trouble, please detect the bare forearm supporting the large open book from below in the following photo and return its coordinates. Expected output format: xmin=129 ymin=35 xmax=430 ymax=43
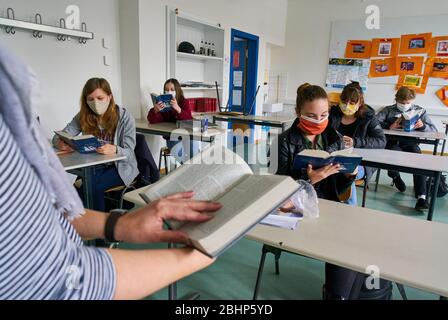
xmin=109 ymin=249 xmax=213 ymax=300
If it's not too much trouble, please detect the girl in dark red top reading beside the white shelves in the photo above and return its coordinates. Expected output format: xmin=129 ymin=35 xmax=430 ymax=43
xmin=148 ymin=79 xmax=199 ymax=162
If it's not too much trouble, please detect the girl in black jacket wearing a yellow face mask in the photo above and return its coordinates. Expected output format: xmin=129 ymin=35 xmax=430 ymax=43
xmin=330 ymin=82 xmax=387 ymax=206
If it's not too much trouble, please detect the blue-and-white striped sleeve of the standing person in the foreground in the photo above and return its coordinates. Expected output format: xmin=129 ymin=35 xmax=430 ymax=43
xmin=0 ymin=115 xmax=116 ymax=300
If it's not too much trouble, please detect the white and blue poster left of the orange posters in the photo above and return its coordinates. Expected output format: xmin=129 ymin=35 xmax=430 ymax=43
xmin=326 ymin=59 xmax=370 ymax=91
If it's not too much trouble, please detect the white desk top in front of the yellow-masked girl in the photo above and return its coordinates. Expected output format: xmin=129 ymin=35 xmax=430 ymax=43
xmin=353 ymin=149 xmax=448 ymax=172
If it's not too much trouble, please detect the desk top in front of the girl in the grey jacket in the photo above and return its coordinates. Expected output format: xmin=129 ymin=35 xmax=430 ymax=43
xmin=59 ymin=152 xmax=126 ymax=171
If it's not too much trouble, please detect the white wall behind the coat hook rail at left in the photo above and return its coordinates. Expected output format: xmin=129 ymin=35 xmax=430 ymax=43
xmin=0 ymin=0 xmax=122 ymax=136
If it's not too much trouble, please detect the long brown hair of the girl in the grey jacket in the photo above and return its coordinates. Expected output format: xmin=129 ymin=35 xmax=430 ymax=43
xmin=80 ymin=78 xmax=119 ymax=137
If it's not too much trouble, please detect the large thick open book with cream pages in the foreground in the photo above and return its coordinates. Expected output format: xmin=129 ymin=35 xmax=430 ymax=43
xmin=141 ymin=145 xmax=299 ymax=257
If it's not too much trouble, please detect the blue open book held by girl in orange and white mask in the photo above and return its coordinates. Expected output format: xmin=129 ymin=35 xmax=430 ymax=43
xmin=294 ymin=149 xmax=362 ymax=173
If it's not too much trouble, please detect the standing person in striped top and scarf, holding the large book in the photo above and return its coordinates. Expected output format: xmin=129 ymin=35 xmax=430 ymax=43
xmin=0 ymin=46 xmax=221 ymax=300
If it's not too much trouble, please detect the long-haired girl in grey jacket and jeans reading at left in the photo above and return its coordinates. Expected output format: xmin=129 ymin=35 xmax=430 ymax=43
xmin=53 ymin=78 xmax=139 ymax=211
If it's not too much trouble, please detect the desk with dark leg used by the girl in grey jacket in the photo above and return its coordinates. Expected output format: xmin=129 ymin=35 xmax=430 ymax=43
xmin=58 ymin=152 xmax=126 ymax=209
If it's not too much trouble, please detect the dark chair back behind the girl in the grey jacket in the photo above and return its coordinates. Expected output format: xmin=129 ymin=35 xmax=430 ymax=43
xmin=135 ymin=134 xmax=160 ymax=187
